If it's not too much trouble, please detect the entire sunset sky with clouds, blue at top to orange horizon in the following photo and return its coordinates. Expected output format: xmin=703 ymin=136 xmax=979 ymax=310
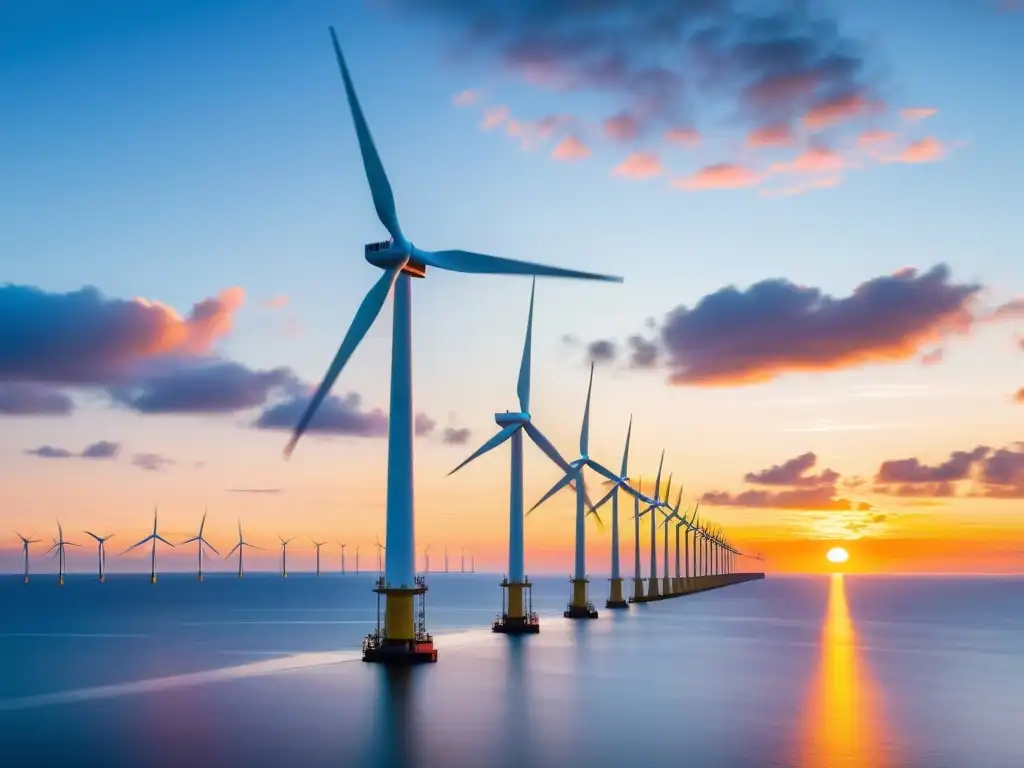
xmin=0 ymin=0 xmax=1024 ymax=573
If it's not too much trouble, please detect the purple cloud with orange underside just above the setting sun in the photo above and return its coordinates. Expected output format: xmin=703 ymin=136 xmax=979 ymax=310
xmin=700 ymin=453 xmax=873 ymax=512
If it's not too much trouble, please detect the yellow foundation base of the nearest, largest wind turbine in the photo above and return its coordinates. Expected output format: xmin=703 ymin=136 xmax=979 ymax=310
xmin=362 ymin=577 xmax=437 ymax=667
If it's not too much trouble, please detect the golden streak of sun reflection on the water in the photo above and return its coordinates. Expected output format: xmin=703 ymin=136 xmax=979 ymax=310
xmin=800 ymin=573 xmax=891 ymax=768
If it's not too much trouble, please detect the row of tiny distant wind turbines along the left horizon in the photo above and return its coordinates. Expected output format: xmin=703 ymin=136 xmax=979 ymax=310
xmin=14 ymin=518 xmax=476 ymax=585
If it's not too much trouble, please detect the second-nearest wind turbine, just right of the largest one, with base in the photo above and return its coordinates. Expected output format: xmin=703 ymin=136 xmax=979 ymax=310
xmin=449 ymin=278 xmax=571 ymax=635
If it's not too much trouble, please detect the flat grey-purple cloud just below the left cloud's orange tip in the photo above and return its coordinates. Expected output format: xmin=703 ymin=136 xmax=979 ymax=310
xmin=110 ymin=358 xmax=300 ymax=415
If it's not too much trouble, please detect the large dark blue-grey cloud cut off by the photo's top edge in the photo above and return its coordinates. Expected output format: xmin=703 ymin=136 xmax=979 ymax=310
xmin=399 ymin=0 xmax=871 ymax=140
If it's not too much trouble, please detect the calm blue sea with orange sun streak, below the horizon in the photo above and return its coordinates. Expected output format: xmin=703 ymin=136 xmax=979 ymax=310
xmin=0 ymin=573 xmax=1024 ymax=768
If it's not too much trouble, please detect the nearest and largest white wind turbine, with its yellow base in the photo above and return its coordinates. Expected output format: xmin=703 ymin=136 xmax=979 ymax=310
xmin=285 ymin=27 xmax=622 ymax=662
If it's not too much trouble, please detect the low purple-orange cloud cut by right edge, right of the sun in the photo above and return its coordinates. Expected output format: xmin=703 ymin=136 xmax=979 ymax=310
xmin=874 ymin=442 xmax=1024 ymax=499
